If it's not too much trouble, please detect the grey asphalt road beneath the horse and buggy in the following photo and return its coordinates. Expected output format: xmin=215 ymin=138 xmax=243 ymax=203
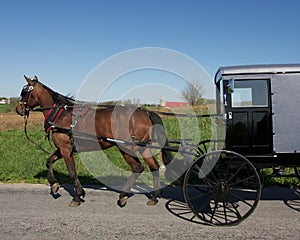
xmin=0 ymin=184 xmax=300 ymax=240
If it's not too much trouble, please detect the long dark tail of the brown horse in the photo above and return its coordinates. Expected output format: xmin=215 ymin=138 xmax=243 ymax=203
xmin=149 ymin=111 xmax=173 ymax=165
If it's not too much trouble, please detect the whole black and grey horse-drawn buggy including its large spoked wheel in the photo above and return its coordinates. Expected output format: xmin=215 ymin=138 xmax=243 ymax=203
xmin=184 ymin=64 xmax=300 ymax=225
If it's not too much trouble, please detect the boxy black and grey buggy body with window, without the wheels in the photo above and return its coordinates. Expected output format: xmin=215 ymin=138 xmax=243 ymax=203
xmin=215 ymin=64 xmax=300 ymax=167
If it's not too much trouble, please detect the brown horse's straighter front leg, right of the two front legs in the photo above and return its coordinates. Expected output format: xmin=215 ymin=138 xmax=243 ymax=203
xmin=63 ymin=151 xmax=85 ymax=207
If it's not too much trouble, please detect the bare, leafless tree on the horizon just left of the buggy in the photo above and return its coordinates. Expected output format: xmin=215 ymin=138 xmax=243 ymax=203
xmin=181 ymin=81 xmax=203 ymax=106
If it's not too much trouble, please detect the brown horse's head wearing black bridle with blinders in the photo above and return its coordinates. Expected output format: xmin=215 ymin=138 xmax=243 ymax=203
xmin=16 ymin=75 xmax=40 ymax=117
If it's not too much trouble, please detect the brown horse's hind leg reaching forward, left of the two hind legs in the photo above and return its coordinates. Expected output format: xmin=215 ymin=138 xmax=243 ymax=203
xmin=118 ymin=151 xmax=144 ymax=207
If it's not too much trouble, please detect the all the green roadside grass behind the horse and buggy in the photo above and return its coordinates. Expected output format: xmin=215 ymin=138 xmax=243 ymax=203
xmin=0 ymin=113 xmax=299 ymax=187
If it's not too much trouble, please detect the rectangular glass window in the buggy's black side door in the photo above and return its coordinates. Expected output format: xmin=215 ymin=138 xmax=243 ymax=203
xmin=231 ymin=80 xmax=268 ymax=107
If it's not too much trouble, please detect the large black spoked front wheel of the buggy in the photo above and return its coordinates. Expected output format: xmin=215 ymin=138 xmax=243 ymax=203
xmin=183 ymin=150 xmax=261 ymax=225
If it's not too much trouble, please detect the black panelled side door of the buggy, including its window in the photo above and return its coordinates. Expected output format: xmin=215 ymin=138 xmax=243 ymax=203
xmin=223 ymin=79 xmax=272 ymax=154
